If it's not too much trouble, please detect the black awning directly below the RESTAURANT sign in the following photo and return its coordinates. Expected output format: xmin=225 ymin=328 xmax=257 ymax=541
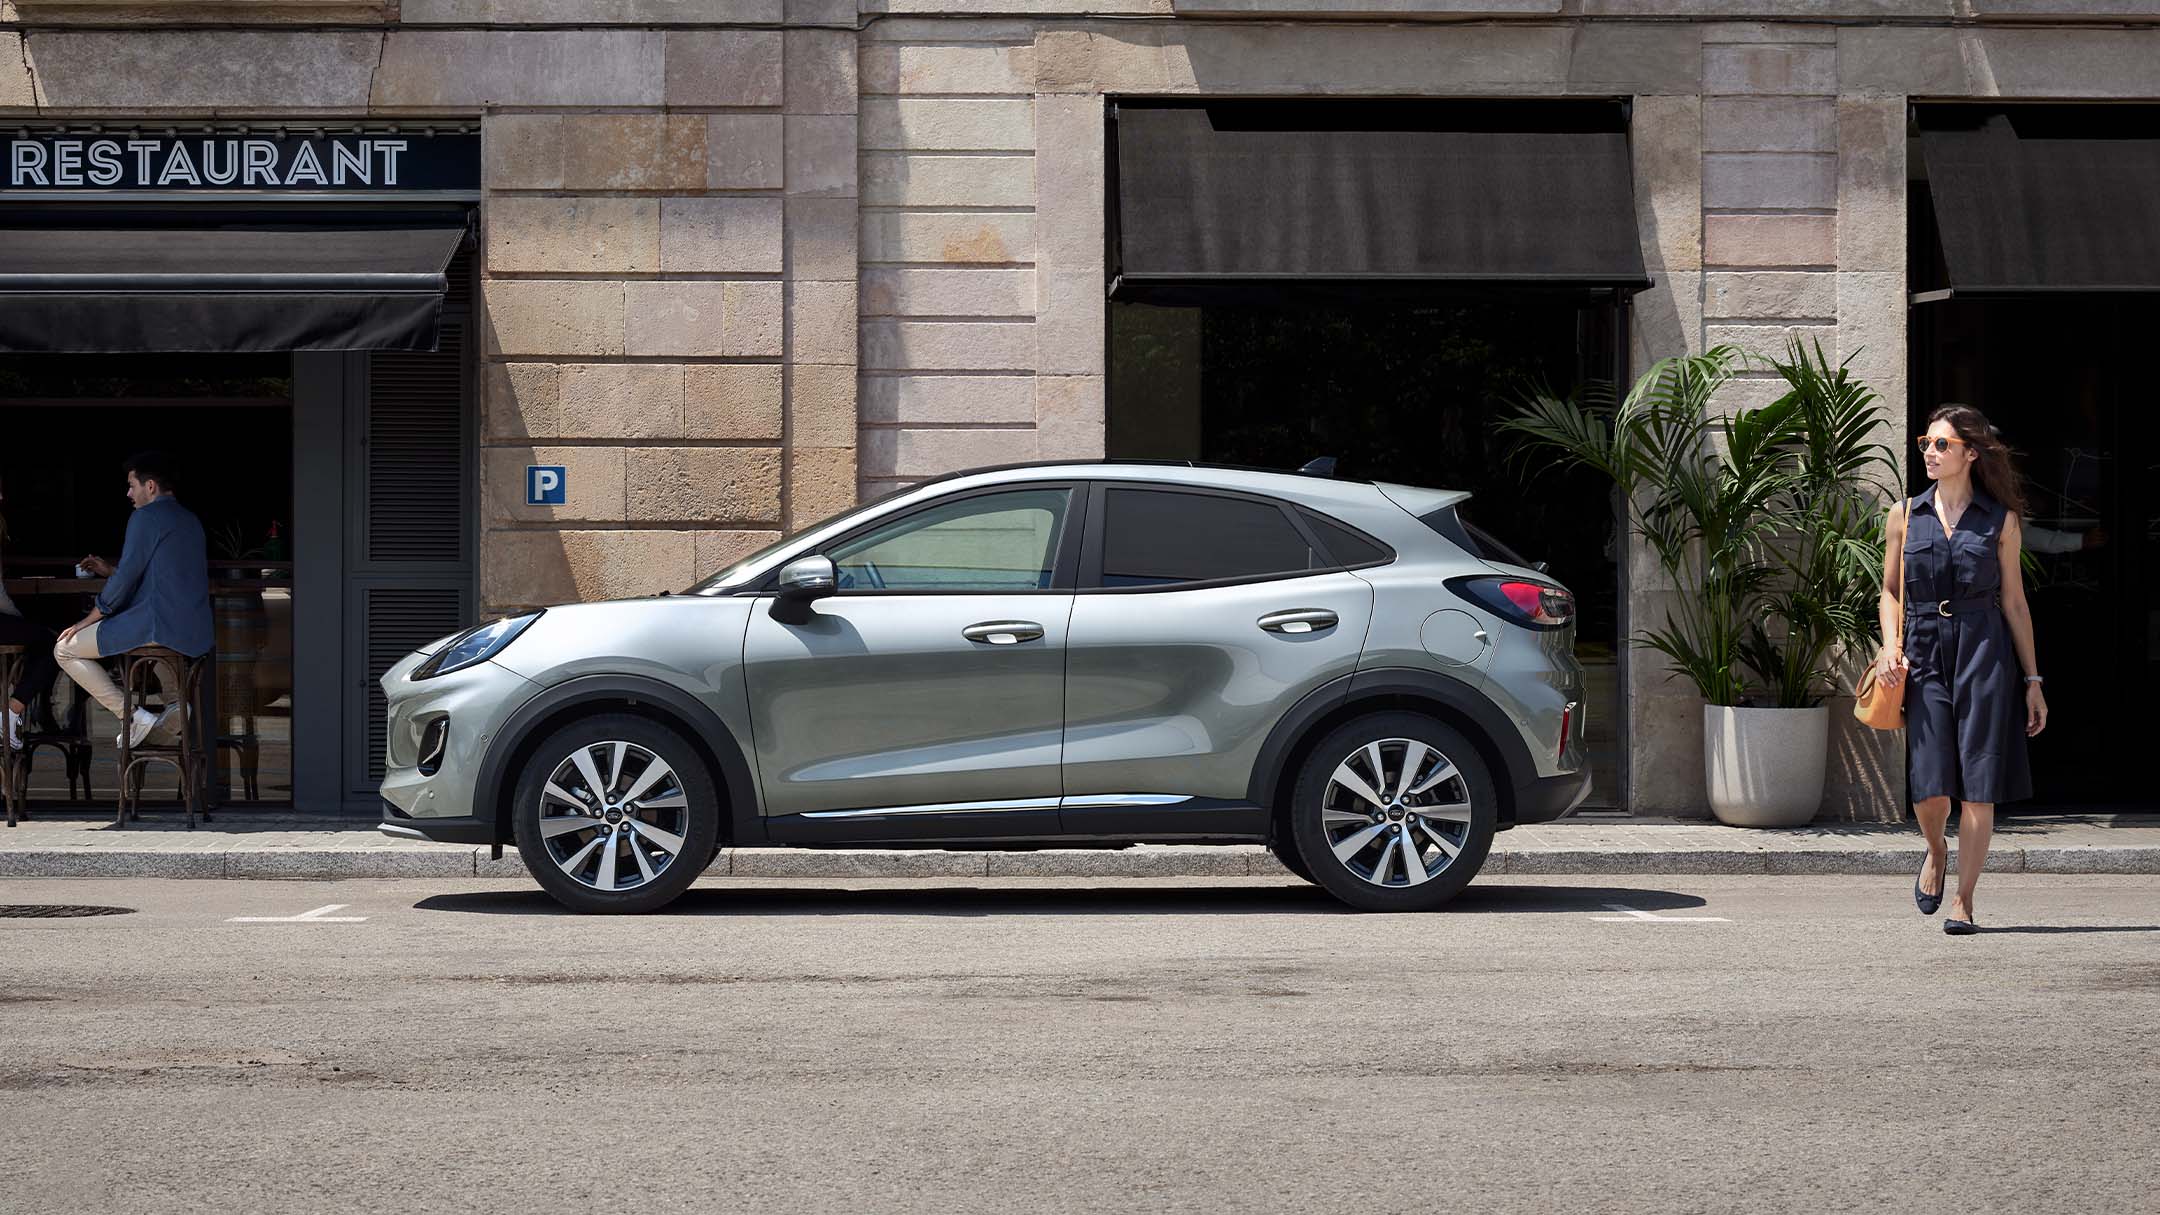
xmin=0 ymin=210 xmax=464 ymax=352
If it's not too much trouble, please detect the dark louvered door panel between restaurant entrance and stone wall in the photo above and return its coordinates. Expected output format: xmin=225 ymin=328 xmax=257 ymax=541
xmin=346 ymin=317 xmax=475 ymax=800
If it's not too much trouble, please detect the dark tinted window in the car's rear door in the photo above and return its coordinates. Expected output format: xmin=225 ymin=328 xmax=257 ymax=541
xmin=1102 ymin=489 xmax=1333 ymax=586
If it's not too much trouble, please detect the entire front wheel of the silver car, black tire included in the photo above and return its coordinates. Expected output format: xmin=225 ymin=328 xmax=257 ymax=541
xmin=512 ymin=713 xmax=719 ymax=914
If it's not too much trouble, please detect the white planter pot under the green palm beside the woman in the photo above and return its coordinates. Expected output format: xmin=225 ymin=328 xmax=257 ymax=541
xmin=1702 ymin=705 xmax=1830 ymax=826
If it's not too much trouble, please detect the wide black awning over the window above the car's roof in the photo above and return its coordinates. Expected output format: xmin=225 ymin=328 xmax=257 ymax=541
xmin=1112 ymin=99 xmax=1650 ymax=298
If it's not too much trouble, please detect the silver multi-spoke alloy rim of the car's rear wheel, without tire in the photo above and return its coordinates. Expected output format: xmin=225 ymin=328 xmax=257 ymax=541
xmin=1320 ymin=737 xmax=1471 ymax=889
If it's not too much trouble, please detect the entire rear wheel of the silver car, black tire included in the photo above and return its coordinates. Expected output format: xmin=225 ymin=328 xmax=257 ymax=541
xmin=1290 ymin=711 xmax=1499 ymax=912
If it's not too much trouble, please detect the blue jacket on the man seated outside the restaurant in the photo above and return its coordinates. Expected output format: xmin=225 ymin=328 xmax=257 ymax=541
xmin=97 ymin=497 xmax=216 ymax=657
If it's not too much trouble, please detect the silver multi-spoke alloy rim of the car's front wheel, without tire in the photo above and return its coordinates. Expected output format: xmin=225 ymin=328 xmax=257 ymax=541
xmin=540 ymin=739 xmax=689 ymax=893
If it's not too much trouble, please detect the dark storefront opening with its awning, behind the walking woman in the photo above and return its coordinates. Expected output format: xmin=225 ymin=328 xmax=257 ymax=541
xmin=1905 ymin=106 xmax=2160 ymax=813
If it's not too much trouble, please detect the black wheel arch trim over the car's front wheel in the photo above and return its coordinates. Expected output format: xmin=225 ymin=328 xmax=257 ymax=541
xmin=473 ymin=675 xmax=762 ymax=845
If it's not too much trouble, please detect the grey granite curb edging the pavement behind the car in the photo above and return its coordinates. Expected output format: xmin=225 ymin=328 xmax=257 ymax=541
xmin=0 ymin=843 xmax=2160 ymax=880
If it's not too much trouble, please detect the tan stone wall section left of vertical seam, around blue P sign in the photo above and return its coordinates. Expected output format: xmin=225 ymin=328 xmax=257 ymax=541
xmin=0 ymin=15 xmax=858 ymax=612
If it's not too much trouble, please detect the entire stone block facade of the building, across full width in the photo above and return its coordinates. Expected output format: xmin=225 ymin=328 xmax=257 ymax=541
xmin=0 ymin=0 xmax=2160 ymax=815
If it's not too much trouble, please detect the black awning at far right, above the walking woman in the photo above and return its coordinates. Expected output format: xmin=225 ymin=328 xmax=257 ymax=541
xmin=1920 ymin=106 xmax=2160 ymax=298
